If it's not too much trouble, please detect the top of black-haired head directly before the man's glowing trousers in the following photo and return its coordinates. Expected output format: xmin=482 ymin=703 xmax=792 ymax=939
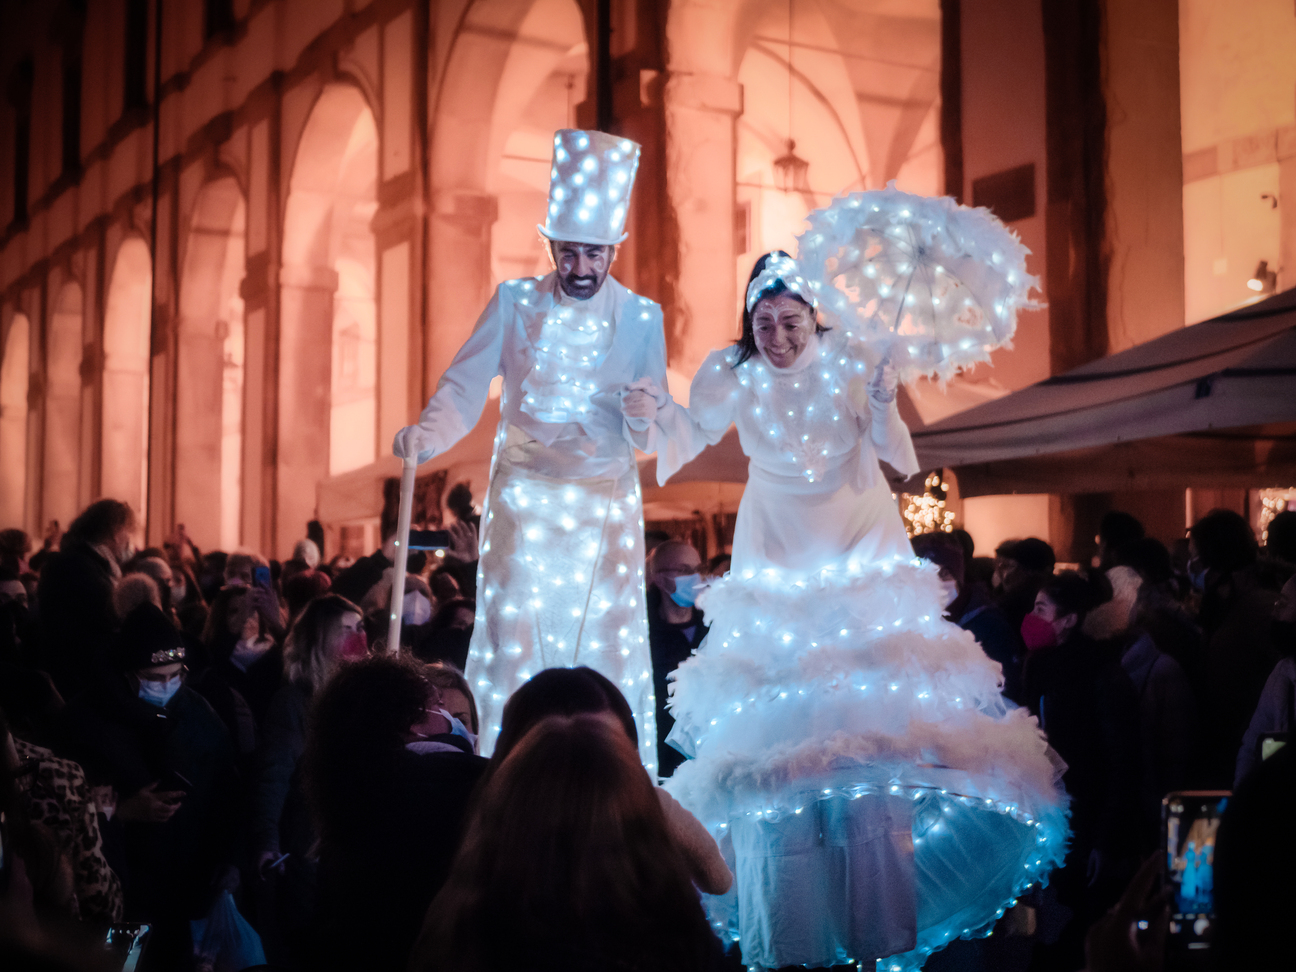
xmin=491 ymin=666 xmax=639 ymax=769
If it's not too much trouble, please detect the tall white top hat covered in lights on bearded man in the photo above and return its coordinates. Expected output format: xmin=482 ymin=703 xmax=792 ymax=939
xmin=539 ymin=128 xmax=639 ymax=246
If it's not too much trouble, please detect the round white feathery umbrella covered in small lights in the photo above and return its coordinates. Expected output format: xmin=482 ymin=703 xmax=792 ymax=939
xmin=797 ymin=183 xmax=1041 ymax=381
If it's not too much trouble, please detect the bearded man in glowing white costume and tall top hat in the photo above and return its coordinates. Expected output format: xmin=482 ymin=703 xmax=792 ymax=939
xmin=393 ymin=130 xmax=666 ymax=772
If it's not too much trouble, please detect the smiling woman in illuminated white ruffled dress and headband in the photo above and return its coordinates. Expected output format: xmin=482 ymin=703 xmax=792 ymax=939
xmin=640 ymin=254 xmax=1065 ymax=969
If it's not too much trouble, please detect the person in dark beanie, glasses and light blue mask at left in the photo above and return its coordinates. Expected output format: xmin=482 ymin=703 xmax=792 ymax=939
xmin=58 ymin=603 xmax=237 ymax=967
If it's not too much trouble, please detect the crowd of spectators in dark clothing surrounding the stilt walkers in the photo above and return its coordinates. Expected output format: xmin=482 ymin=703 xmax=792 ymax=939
xmin=0 ymin=489 xmax=1296 ymax=972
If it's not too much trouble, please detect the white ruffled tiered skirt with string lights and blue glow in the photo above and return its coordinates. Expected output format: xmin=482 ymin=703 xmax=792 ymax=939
xmin=666 ymin=559 xmax=1067 ymax=969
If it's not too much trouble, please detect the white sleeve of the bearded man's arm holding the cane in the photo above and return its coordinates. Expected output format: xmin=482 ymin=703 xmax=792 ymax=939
xmin=419 ymin=288 xmax=512 ymax=455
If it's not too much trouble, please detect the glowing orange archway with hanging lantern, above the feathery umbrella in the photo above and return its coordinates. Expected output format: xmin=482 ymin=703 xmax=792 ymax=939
xmin=664 ymin=0 xmax=942 ymax=373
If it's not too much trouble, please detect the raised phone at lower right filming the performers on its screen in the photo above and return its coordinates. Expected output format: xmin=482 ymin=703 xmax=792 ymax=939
xmin=1161 ymin=791 xmax=1231 ymax=967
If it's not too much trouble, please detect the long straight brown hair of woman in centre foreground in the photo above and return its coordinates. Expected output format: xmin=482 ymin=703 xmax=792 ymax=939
xmin=410 ymin=717 xmax=714 ymax=972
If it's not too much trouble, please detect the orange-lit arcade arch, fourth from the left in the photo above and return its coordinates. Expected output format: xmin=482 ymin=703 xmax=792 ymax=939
xmin=175 ymin=176 xmax=246 ymax=550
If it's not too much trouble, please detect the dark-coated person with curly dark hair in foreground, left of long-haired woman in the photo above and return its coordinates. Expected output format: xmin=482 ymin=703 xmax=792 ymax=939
xmin=303 ymin=654 xmax=487 ymax=972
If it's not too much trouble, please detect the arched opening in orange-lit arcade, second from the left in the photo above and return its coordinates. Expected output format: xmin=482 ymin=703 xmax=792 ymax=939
xmin=40 ymin=280 xmax=83 ymax=529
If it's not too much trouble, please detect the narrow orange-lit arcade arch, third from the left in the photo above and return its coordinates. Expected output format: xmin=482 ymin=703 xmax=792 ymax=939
xmin=100 ymin=236 xmax=153 ymax=518
